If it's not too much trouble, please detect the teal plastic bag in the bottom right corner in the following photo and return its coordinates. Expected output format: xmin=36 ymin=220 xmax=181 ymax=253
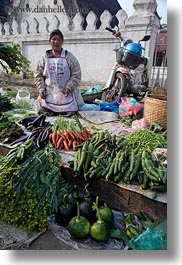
xmin=129 ymin=221 xmax=167 ymax=250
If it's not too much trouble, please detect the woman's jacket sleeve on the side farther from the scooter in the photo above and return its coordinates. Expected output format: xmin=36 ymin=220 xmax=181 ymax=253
xmin=34 ymin=56 xmax=46 ymax=92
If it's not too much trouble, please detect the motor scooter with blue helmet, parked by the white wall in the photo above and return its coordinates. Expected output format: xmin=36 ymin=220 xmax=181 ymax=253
xmin=101 ymin=27 xmax=150 ymax=102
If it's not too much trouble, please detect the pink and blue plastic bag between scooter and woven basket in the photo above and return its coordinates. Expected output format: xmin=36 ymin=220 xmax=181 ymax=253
xmin=119 ymin=97 xmax=141 ymax=116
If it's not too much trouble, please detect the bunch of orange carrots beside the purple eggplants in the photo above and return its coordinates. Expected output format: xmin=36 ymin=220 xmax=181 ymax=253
xmin=49 ymin=128 xmax=92 ymax=151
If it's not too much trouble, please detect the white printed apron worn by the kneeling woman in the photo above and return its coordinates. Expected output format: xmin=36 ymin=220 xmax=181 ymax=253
xmin=39 ymin=49 xmax=78 ymax=113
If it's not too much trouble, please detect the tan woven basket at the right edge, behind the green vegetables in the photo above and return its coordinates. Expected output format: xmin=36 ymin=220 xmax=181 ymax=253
xmin=144 ymin=94 xmax=167 ymax=129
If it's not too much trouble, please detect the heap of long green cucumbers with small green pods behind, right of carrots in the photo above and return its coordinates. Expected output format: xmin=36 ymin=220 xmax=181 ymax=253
xmin=73 ymin=130 xmax=167 ymax=191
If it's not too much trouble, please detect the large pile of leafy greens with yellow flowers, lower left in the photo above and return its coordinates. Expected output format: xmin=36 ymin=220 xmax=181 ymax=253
xmin=0 ymin=141 xmax=70 ymax=232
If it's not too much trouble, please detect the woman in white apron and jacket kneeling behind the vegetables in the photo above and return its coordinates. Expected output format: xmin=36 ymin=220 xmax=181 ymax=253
xmin=35 ymin=29 xmax=83 ymax=116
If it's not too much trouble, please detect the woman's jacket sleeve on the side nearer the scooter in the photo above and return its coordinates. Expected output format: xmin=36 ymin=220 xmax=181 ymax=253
xmin=66 ymin=52 xmax=81 ymax=91
